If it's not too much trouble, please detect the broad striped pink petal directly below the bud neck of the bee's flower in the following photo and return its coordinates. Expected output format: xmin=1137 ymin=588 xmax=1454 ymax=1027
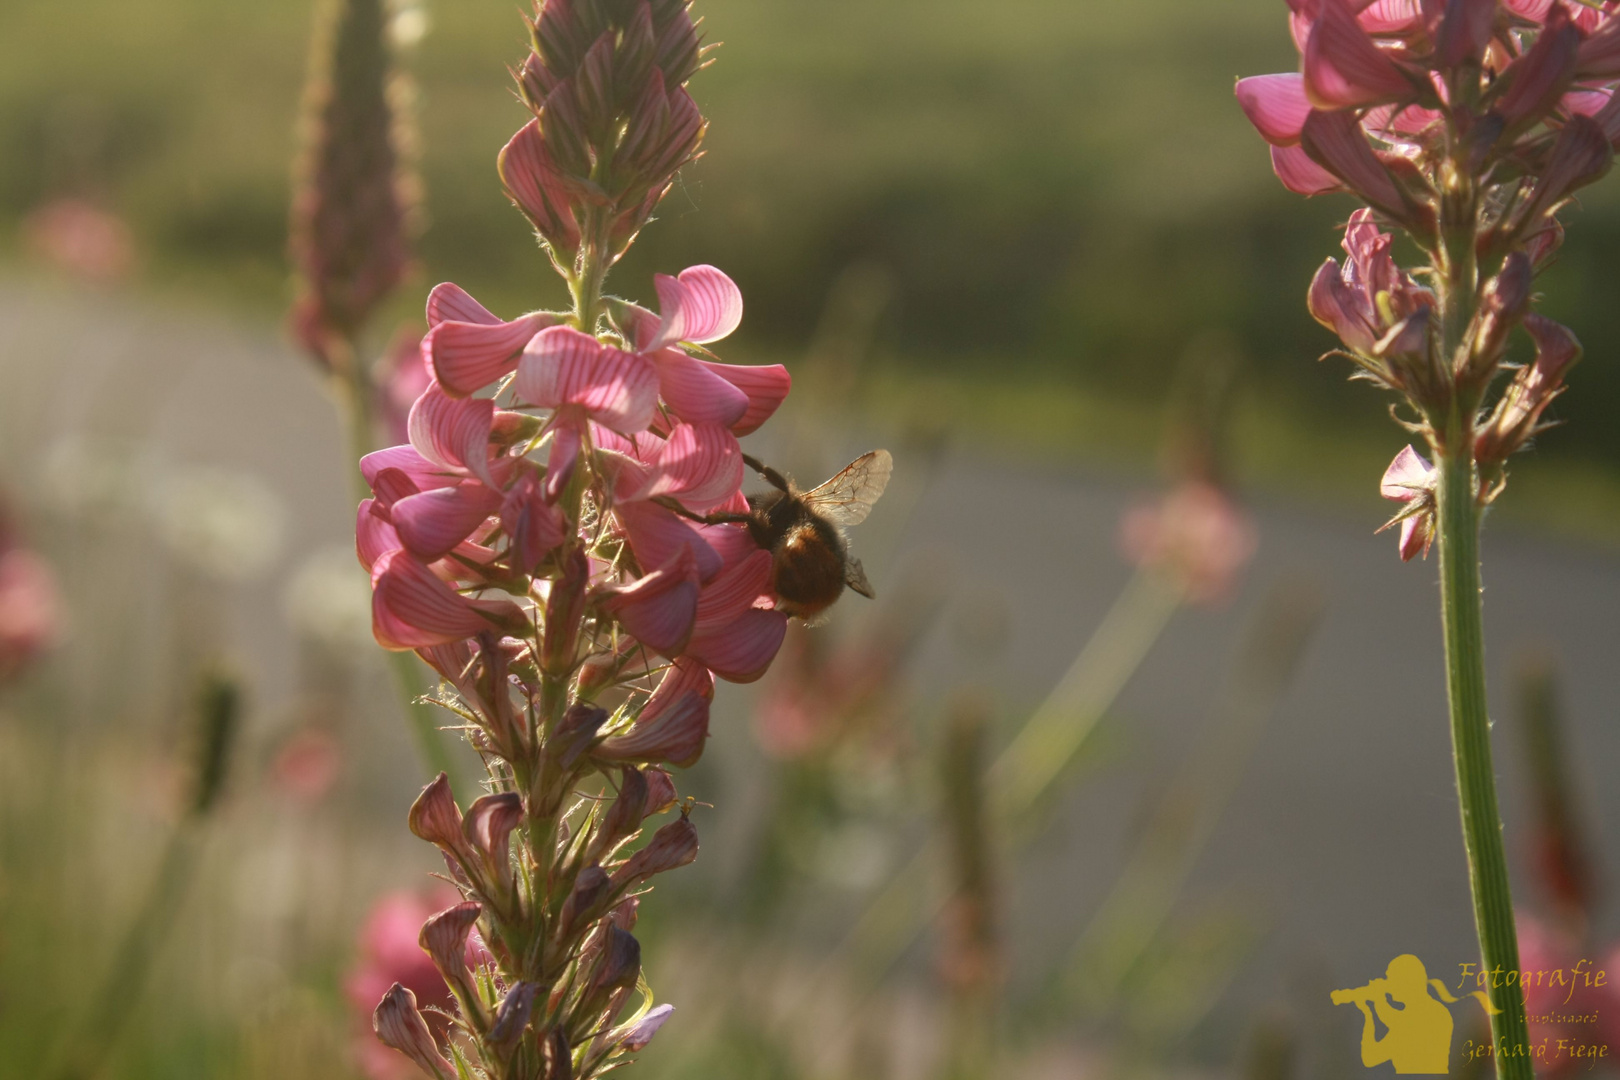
xmin=515 ymin=325 xmax=658 ymax=434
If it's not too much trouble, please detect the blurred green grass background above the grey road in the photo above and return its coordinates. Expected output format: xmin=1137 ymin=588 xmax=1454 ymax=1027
xmin=0 ymin=0 xmax=1620 ymax=534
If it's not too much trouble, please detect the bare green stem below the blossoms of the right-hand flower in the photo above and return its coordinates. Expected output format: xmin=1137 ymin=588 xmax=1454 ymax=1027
xmin=1439 ymin=443 xmax=1534 ymax=1080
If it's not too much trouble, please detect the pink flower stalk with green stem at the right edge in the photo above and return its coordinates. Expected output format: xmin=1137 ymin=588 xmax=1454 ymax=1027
xmin=1236 ymin=0 xmax=1620 ymax=1078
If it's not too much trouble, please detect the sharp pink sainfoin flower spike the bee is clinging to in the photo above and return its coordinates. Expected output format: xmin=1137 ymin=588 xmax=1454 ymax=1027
xmin=355 ymin=0 xmax=874 ymax=1080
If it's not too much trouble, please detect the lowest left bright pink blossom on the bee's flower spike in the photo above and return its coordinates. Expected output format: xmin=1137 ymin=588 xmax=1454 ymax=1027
xmin=371 ymin=551 xmax=528 ymax=653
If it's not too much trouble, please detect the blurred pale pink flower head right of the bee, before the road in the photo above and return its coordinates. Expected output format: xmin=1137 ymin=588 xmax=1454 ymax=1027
xmin=1119 ymin=481 xmax=1259 ymax=602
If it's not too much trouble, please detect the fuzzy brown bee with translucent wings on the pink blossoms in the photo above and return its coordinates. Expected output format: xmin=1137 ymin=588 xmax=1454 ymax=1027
xmin=747 ymin=450 xmax=894 ymax=619
